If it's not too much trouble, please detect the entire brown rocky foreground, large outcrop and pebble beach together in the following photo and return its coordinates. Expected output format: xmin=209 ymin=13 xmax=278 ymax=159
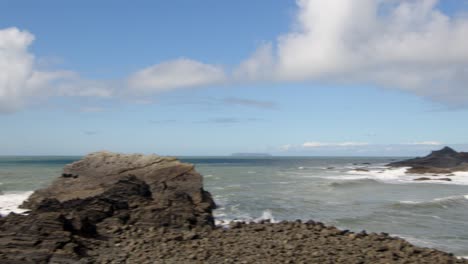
xmin=0 ymin=152 xmax=468 ymax=263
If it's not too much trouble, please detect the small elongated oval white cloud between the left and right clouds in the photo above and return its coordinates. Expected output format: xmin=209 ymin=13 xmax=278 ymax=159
xmin=128 ymin=59 xmax=226 ymax=92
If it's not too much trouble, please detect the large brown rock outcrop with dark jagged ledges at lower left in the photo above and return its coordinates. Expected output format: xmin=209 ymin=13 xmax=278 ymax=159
xmin=0 ymin=152 xmax=215 ymax=263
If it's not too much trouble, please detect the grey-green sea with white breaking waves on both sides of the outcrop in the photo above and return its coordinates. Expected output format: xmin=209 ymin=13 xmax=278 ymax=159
xmin=0 ymin=156 xmax=468 ymax=256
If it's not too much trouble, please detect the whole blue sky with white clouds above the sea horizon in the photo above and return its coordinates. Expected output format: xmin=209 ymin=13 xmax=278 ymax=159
xmin=0 ymin=0 xmax=468 ymax=156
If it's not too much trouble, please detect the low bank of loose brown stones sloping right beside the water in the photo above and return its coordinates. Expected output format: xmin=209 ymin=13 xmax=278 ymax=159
xmin=90 ymin=221 xmax=468 ymax=264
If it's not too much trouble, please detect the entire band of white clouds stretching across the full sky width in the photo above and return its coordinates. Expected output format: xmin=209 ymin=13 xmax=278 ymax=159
xmin=0 ymin=0 xmax=468 ymax=112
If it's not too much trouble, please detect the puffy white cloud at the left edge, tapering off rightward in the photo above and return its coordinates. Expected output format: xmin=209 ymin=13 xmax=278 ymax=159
xmin=0 ymin=28 xmax=111 ymax=112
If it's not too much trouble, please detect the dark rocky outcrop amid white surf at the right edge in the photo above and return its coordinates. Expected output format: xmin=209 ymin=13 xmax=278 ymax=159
xmin=388 ymin=147 xmax=468 ymax=174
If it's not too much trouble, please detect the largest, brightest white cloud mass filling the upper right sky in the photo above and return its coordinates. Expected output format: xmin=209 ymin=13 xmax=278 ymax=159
xmin=238 ymin=0 xmax=468 ymax=104
